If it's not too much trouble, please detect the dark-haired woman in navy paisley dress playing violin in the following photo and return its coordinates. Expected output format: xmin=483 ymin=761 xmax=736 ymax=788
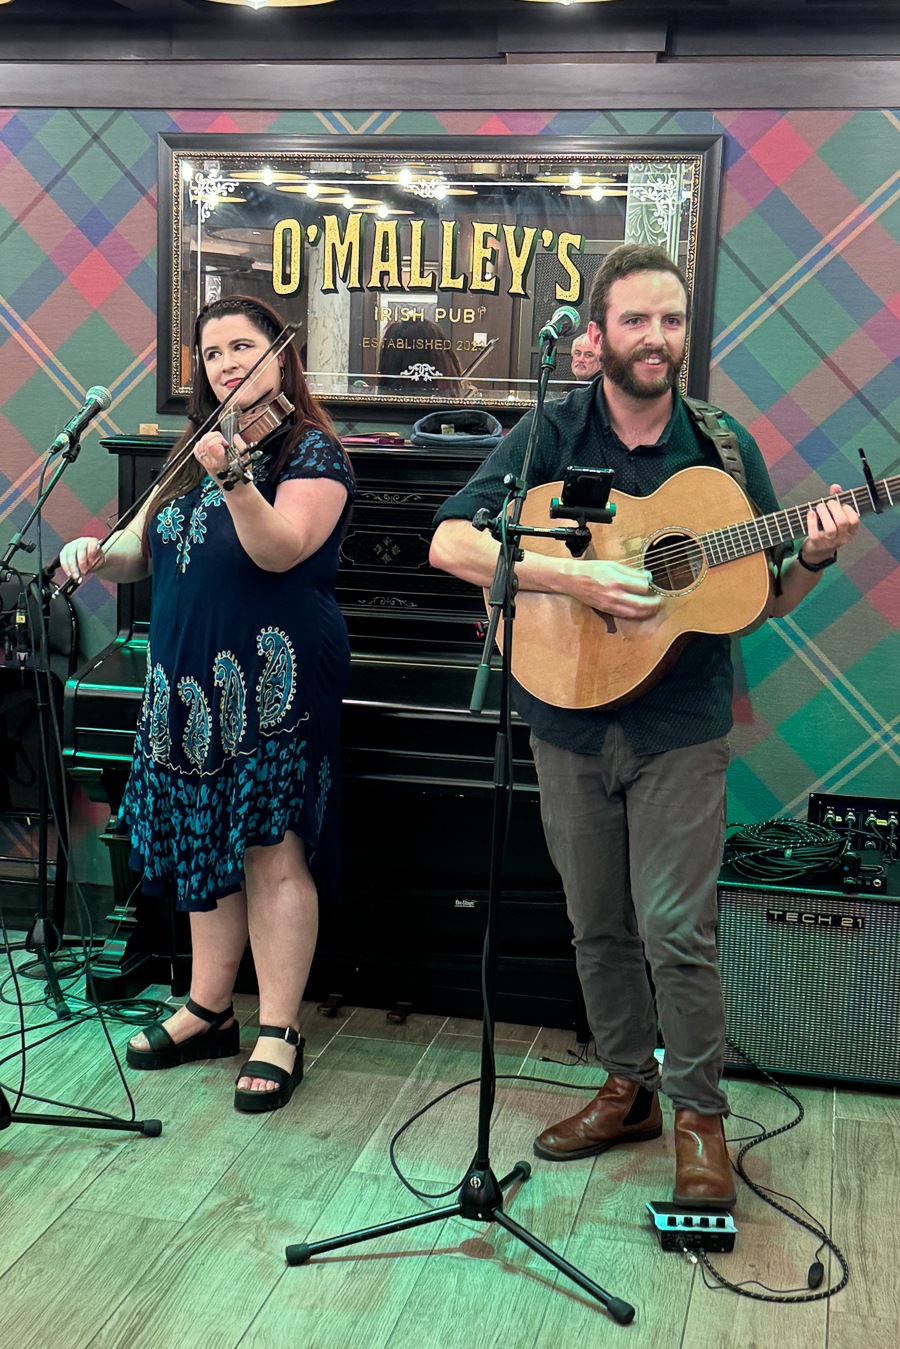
xmin=61 ymin=295 xmax=354 ymax=1112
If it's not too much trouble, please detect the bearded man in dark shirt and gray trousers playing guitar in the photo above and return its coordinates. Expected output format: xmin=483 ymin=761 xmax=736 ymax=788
xmin=430 ymin=244 xmax=858 ymax=1207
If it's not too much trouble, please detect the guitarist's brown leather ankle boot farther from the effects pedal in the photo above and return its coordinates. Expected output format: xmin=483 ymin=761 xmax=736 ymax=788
xmin=534 ymin=1077 xmax=663 ymax=1161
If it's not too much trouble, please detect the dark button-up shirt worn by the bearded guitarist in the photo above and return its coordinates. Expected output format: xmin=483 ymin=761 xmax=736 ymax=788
xmin=434 ymin=379 xmax=779 ymax=754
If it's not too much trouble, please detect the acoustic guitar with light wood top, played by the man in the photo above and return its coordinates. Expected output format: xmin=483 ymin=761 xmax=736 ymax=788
xmin=496 ymin=467 xmax=900 ymax=707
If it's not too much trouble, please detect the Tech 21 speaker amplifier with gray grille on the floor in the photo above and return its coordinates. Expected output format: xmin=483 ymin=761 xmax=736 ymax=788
xmin=718 ymin=866 xmax=900 ymax=1087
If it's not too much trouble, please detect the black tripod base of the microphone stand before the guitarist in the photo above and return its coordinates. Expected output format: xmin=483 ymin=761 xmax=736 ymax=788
xmin=285 ymin=1161 xmax=634 ymax=1326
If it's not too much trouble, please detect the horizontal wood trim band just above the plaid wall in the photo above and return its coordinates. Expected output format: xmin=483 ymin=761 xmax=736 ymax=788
xmin=0 ymin=61 xmax=900 ymax=111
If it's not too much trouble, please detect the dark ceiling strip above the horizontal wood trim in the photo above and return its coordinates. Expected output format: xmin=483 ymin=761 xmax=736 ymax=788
xmin=0 ymin=0 xmax=900 ymax=62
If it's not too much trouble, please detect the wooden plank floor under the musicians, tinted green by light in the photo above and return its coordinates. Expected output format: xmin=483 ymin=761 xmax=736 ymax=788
xmin=0 ymin=983 xmax=900 ymax=1349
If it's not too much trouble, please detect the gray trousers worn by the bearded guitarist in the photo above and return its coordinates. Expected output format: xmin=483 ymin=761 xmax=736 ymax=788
xmin=532 ymin=723 xmax=729 ymax=1114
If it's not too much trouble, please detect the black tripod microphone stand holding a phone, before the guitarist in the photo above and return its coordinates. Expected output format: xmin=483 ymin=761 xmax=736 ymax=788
xmin=285 ymin=331 xmax=634 ymax=1326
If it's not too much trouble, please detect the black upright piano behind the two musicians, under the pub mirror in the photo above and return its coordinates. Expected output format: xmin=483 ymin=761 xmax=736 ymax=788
xmin=65 ymin=434 xmax=580 ymax=1027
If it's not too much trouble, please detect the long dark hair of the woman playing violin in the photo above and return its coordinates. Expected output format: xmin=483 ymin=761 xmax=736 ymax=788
xmin=142 ymin=295 xmax=354 ymax=557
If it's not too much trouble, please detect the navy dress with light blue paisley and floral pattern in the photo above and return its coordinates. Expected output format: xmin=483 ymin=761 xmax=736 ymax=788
xmin=120 ymin=429 xmax=354 ymax=911
